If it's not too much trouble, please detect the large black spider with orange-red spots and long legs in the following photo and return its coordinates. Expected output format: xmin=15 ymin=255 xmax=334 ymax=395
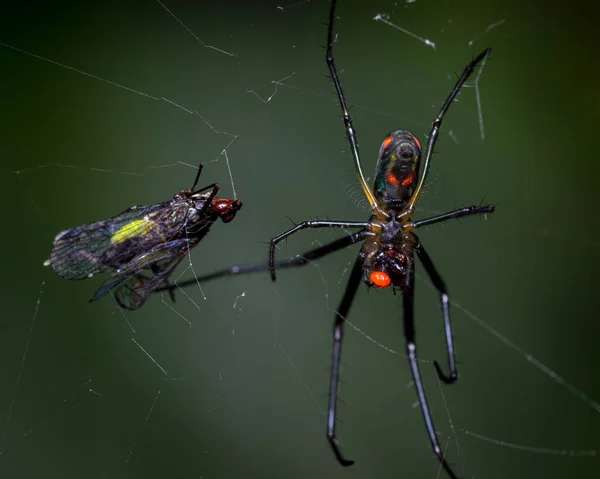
xmin=161 ymin=0 xmax=494 ymax=478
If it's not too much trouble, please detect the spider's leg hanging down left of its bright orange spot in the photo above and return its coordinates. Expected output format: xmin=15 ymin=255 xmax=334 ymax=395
xmin=327 ymin=255 xmax=363 ymax=466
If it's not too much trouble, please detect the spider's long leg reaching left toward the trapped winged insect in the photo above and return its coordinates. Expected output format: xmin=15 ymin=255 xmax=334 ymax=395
xmin=157 ymin=231 xmax=369 ymax=294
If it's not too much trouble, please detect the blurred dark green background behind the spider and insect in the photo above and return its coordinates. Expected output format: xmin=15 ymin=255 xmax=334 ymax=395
xmin=0 ymin=0 xmax=600 ymax=479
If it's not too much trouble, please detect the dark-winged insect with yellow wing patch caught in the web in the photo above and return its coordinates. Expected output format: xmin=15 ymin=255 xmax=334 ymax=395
xmin=44 ymin=164 xmax=242 ymax=310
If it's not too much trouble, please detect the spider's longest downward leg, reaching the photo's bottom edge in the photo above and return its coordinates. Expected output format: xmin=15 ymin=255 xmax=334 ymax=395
xmin=402 ymin=268 xmax=457 ymax=479
